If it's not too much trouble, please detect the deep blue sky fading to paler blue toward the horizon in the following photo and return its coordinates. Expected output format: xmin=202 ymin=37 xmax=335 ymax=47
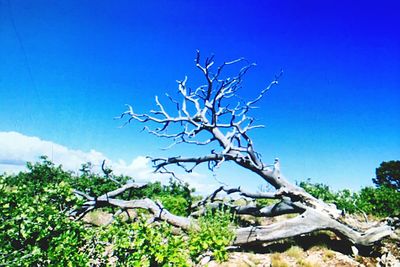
xmin=0 ymin=0 xmax=400 ymax=193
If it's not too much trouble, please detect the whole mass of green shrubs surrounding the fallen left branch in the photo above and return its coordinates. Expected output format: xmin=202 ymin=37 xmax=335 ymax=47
xmin=0 ymin=157 xmax=234 ymax=266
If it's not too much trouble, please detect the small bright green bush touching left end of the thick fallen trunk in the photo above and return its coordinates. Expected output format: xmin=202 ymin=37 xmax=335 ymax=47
xmin=189 ymin=209 xmax=235 ymax=262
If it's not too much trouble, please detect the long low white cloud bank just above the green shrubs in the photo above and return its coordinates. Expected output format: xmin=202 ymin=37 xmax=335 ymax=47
xmin=0 ymin=132 xmax=217 ymax=194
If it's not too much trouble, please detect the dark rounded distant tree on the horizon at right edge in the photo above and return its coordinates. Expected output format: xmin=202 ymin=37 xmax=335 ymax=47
xmin=372 ymin=160 xmax=400 ymax=191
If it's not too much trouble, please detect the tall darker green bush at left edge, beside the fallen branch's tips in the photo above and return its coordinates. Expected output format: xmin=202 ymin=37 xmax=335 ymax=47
xmin=0 ymin=158 xmax=88 ymax=266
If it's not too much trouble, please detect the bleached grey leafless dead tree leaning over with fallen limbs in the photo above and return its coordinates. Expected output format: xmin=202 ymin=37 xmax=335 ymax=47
xmin=73 ymin=52 xmax=394 ymax=251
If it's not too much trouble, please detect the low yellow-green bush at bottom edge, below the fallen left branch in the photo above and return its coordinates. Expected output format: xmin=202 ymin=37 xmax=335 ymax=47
xmin=98 ymin=217 xmax=189 ymax=266
